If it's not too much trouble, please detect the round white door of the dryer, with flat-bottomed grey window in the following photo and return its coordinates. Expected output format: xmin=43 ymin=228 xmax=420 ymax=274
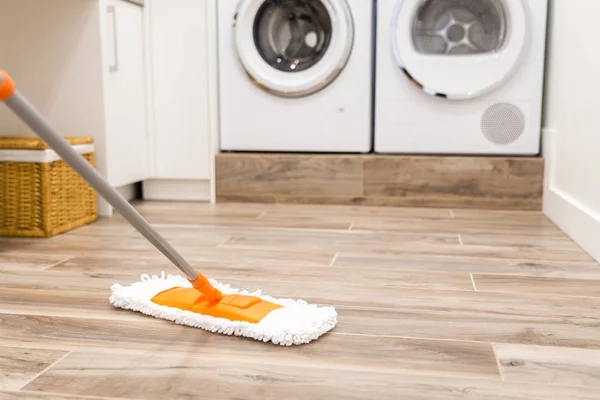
xmin=391 ymin=0 xmax=527 ymax=99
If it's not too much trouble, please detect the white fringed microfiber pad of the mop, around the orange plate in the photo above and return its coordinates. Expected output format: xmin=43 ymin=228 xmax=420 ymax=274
xmin=110 ymin=272 xmax=337 ymax=346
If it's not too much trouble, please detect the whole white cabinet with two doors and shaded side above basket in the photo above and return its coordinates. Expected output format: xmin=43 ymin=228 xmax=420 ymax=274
xmin=0 ymin=0 xmax=218 ymax=215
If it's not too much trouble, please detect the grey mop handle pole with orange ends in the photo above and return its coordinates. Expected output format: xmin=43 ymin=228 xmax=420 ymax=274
xmin=0 ymin=70 xmax=210 ymax=293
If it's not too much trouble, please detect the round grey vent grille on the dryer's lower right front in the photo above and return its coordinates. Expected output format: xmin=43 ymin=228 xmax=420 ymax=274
xmin=481 ymin=103 xmax=525 ymax=144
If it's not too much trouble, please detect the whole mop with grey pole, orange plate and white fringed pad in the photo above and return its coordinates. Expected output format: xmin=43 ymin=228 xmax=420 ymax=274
xmin=0 ymin=70 xmax=337 ymax=346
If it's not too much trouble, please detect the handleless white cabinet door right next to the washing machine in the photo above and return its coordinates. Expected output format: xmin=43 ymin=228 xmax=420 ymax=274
xmin=149 ymin=0 xmax=212 ymax=180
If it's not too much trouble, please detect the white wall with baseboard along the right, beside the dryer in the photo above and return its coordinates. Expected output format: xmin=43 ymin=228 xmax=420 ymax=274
xmin=544 ymin=0 xmax=600 ymax=261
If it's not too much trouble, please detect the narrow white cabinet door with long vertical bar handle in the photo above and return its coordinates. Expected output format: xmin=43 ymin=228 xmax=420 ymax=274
xmin=104 ymin=0 xmax=150 ymax=186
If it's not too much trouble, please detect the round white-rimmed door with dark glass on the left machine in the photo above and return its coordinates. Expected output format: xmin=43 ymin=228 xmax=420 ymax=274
xmin=234 ymin=0 xmax=354 ymax=97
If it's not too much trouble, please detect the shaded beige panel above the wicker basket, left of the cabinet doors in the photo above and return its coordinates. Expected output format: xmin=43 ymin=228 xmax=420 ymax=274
xmin=0 ymin=0 xmax=104 ymax=142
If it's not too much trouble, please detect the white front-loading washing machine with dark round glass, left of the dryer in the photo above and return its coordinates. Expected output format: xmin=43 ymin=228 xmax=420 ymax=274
xmin=217 ymin=0 xmax=373 ymax=153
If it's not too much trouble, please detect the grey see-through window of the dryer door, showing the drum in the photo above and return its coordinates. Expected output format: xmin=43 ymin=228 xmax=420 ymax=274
xmin=413 ymin=0 xmax=508 ymax=55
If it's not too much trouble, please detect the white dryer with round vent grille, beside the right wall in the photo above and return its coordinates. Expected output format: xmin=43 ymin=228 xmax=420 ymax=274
xmin=375 ymin=0 xmax=548 ymax=155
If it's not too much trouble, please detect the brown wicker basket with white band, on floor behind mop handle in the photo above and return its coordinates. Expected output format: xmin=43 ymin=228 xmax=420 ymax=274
xmin=0 ymin=137 xmax=98 ymax=237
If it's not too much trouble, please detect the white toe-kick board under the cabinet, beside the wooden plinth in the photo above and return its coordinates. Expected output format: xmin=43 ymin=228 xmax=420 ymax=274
xmin=143 ymin=179 xmax=211 ymax=201
